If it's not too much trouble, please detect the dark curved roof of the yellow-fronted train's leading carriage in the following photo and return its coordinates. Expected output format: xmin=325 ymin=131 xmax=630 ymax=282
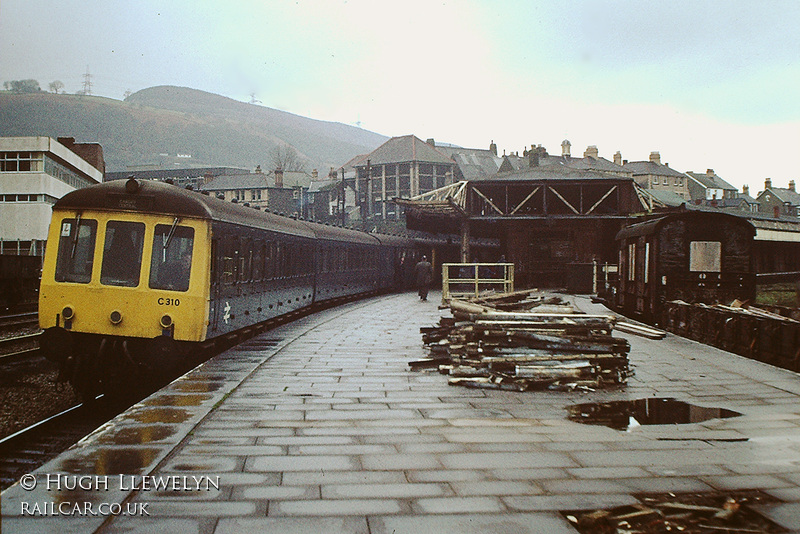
xmin=53 ymin=180 xmax=318 ymax=238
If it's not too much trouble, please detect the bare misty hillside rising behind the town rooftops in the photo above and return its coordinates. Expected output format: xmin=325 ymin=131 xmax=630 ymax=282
xmin=0 ymin=86 xmax=387 ymax=175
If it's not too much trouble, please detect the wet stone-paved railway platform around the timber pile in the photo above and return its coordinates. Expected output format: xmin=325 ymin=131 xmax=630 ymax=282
xmin=1 ymin=293 xmax=800 ymax=534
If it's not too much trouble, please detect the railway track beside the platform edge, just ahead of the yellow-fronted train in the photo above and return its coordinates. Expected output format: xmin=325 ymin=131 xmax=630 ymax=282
xmin=0 ymin=398 xmax=123 ymax=491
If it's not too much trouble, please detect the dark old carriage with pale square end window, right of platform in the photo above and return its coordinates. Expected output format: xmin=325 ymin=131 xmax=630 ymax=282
xmin=614 ymin=211 xmax=755 ymax=324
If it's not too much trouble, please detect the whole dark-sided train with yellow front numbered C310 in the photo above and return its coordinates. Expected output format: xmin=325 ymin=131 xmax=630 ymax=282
xmin=39 ymin=178 xmax=444 ymax=398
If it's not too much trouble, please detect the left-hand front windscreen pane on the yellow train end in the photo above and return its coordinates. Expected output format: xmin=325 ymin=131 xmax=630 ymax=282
xmin=56 ymin=217 xmax=97 ymax=284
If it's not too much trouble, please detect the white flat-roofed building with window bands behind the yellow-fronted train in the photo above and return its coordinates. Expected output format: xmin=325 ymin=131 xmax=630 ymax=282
xmin=0 ymin=137 xmax=105 ymax=256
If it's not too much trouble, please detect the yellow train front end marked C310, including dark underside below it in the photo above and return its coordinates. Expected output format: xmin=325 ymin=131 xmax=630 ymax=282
xmin=39 ymin=204 xmax=211 ymax=398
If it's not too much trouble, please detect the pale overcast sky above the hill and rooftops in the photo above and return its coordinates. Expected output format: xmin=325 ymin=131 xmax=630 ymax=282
xmin=0 ymin=0 xmax=800 ymax=194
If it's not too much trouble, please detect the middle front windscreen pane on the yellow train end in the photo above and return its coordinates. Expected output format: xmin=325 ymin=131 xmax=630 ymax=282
xmin=100 ymin=221 xmax=144 ymax=287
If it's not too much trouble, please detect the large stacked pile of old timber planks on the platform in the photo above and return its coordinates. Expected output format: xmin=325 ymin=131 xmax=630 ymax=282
xmin=409 ymin=297 xmax=633 ymax=391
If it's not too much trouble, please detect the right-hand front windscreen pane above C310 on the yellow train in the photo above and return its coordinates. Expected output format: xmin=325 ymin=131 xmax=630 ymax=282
xmin=150 ymin=224 xmax=194 ymax=291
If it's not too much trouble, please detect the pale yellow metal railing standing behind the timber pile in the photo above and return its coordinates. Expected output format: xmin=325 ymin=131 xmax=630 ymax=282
xmin=442 ymin=263 xmax=514 ymax=302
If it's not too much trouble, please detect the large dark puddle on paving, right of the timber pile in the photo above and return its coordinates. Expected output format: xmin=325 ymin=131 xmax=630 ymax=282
xmin=567 ymin=398 xmax=742 ymax=430
